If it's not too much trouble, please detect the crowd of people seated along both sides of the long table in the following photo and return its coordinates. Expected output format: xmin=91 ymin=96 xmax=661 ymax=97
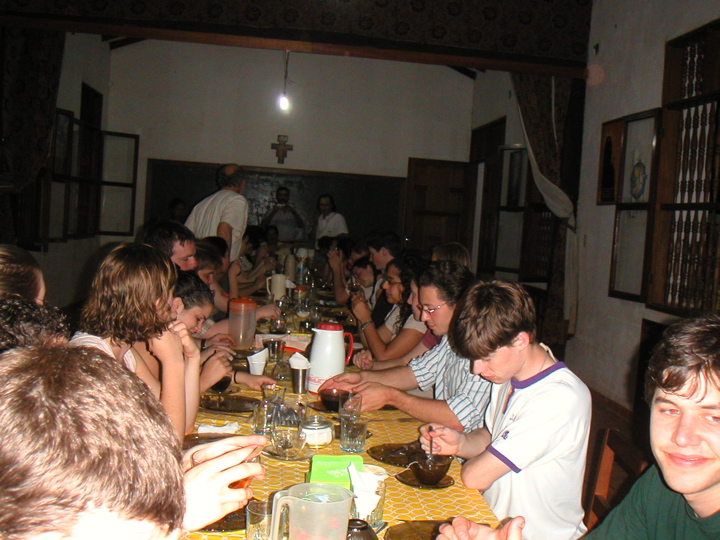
xmin=0 ymin=178 xmax=720 ymax=540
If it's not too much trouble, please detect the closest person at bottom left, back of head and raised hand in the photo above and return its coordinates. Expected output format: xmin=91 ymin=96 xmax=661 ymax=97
xmin=0 ymin=340 xmax=266 ymax=540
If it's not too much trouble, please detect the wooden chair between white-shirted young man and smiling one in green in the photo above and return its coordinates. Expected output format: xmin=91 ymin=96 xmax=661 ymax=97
xmin=585 ymin=429 xmax=650 ymax=531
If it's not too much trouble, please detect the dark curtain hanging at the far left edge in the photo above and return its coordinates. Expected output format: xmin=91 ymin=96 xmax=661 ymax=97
xmin=0 ymin=27 xmax=65 ymax=244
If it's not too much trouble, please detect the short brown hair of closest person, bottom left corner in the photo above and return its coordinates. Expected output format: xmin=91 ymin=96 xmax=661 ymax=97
xmin=0 ymin=344 xmax=185 ymax=540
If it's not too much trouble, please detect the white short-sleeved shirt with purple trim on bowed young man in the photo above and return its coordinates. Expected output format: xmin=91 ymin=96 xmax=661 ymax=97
xmin=483 ymin=345 xmax=592 ymax=540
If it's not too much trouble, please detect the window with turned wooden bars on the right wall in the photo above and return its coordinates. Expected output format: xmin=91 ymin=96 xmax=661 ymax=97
xmin=648 ymin=21 xmax=720 ymax=315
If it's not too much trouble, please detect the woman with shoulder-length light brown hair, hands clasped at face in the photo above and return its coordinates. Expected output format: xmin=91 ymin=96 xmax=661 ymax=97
xmin=72 ymin=243 xmax=200 ymax=438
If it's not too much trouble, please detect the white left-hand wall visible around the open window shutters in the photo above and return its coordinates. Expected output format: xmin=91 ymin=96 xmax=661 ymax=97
xmin=39 ymin=34 xmax=110 ymax=306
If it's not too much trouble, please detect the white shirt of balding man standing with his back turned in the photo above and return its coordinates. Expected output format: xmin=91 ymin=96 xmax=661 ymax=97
xmin=185 ymin=189 xmax=248 ymax=261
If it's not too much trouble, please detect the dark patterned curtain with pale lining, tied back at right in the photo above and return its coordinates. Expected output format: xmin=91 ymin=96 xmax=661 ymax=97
xmin=512 ymin=73 xmax=577 ymax=349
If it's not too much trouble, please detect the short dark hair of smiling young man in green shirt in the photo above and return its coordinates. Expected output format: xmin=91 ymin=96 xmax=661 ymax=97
xmin=645 ymin=315 xmax=720 ymax=403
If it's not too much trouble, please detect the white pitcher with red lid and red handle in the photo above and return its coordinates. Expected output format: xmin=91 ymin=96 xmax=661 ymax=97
xmin=307 ymin=323 xmax=354 ymax=393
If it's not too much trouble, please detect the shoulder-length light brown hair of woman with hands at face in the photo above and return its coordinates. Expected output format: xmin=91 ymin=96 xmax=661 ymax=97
xmin=80 ymin=243 xmax=177 ymax=344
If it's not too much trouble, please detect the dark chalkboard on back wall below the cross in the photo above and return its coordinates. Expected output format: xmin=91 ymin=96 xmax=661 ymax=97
xmin=145 ymin=159 xmax=405 ymax=239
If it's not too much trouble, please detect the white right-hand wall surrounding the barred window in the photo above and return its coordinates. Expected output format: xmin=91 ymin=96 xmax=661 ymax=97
xmin=567 ymin=0 xmax=720 ymax=408
